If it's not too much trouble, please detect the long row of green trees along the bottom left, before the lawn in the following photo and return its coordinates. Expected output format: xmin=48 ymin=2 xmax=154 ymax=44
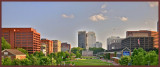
xmin=2 ymin=48 xmax=75 ymax=65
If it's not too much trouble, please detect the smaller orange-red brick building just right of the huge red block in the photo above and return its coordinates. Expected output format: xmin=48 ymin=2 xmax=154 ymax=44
xmin=41 ymin=38 xmax=53 ymax=55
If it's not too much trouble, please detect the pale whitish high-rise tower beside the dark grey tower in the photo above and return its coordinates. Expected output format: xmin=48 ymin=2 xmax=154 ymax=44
xmin=87 ymin=32 xmax=96 ymax=48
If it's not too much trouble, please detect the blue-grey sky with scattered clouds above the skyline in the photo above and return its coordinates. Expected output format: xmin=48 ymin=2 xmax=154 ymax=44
xmin=2 ymin=2 xmax=158 ymax=49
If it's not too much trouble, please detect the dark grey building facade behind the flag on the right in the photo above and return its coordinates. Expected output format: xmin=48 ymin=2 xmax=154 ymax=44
xmin=121 ymin=37 xmax=153 ymax=51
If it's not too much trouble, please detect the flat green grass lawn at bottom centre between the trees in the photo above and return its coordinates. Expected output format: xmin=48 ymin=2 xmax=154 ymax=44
xmin=71 ymin=59 xmax=113 ymax=66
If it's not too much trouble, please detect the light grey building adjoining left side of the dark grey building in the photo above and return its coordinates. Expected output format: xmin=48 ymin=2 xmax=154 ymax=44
xmin=107 ymin=36 xmax=124 ymax=50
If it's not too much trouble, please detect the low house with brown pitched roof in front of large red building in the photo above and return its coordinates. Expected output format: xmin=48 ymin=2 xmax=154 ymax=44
xmin=1 ymin=49 xmax=26 ymax=60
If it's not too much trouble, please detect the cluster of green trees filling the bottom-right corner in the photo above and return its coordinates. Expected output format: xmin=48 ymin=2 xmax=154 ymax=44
xmin=119 ymin=48 xmax=158 ymax=65
